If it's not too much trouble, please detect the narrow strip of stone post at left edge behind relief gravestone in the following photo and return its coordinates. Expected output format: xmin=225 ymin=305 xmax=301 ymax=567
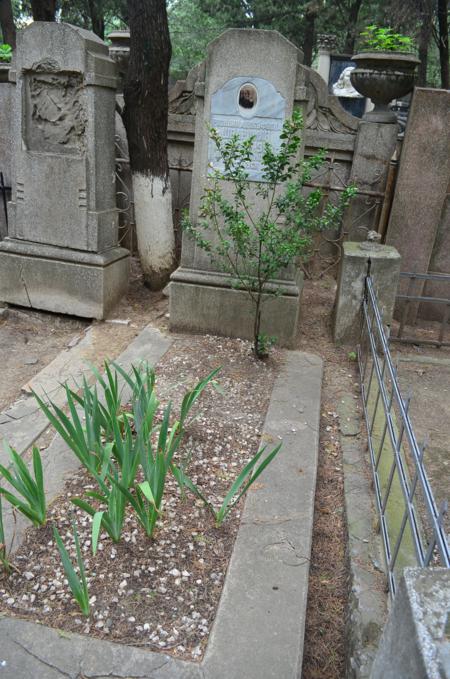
xmin=0 ymin=62 xmax=14 ymax=240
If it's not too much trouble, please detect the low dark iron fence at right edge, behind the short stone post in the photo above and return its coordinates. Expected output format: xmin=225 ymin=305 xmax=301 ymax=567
xmin=391 ymin=271 xmax=450 ymax=347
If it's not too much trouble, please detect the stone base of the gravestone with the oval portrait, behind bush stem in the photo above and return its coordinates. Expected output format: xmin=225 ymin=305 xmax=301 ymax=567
xmin=170 ymin=268 xmax=303 ymax=347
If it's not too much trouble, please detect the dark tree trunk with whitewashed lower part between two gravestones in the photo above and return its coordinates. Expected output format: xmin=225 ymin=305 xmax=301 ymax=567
xmin=123 ymin=0 xmax=175 ymax=290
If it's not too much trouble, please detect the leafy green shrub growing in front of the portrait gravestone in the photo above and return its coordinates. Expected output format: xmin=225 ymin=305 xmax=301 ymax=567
xmin=183 ymin=111 xmax=356 ymax=358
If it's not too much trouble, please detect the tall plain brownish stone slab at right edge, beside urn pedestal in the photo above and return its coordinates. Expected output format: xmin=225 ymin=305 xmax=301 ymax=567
xmin=386 ymin=88 xmax=450 ymax=321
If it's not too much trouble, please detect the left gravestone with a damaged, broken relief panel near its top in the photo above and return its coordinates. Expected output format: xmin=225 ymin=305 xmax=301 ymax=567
xmin=0 ymin=22 xmax=129 ymax=318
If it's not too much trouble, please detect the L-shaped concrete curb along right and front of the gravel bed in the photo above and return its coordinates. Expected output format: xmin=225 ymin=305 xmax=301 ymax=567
xmin=0 ymin=352 xmax=322 ymax=679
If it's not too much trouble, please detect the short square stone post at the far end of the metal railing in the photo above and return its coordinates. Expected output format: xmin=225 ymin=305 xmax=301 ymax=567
xmin=333 ymin=241 xmax=401 ymax=347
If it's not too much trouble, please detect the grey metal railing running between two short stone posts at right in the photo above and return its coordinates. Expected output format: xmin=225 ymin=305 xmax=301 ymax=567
xmin=358 ymin=276 xmax=450 ymax=596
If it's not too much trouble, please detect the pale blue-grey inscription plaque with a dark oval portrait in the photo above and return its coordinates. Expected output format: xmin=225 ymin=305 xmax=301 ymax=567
xmin=208 ymin=76 xmax=286 ymax=181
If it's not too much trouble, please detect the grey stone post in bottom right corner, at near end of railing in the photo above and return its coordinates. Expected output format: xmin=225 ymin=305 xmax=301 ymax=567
xmin=370 ymin=568 xmax=450 ymax=679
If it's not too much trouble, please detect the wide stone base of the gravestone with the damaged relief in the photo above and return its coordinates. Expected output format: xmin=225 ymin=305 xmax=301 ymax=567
xmin=0 ymin=238 xmax=130 ymax=319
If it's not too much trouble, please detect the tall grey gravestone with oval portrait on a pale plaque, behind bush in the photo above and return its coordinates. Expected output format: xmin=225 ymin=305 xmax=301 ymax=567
xmin=170 ymin=29 xmax=306 ymax=345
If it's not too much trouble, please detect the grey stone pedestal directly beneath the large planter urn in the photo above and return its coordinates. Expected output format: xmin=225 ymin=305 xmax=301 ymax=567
xmin=343 ymin=119 xmax=398 ymax=241
